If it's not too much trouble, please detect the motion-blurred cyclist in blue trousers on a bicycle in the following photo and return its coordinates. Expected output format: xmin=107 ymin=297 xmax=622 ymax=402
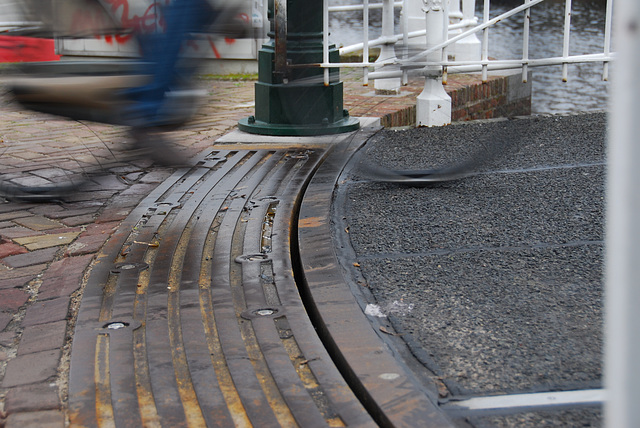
xmin=0 ymin=0 xmax=254 ymax=200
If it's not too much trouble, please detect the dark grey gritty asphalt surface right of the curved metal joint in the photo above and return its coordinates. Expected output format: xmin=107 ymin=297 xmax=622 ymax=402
xmin=336 ymin=113 xmax=606 ymax=426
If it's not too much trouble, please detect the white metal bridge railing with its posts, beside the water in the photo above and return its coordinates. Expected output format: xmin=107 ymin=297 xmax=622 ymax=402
xmin=322 ymin=0 xmax=615 ymax=126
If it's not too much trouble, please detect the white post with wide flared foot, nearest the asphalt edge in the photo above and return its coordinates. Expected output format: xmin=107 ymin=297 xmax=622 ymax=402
xmin=416 ymin=0 xmax=451 ymax=126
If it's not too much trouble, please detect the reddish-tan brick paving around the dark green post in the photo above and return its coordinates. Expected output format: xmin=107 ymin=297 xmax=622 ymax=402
xmin=0 ymin=68 xmax=524 ymax=428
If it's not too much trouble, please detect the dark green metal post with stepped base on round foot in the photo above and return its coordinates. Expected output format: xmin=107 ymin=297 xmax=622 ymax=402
xmin=238 ymin=0 xmax=360 ymax=135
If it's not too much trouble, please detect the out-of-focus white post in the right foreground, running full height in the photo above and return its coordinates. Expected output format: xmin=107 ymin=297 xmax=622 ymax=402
xmin=604 ymin=0 xmax=640 ymax=428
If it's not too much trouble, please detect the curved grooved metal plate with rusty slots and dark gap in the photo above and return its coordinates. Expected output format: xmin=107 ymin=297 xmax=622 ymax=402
xmin=69 ymin=122 xmax=456 ymax=427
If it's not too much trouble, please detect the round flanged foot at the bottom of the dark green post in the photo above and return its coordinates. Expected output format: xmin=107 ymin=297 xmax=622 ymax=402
xmin=238 ymin=116 xmax=360 ymax=136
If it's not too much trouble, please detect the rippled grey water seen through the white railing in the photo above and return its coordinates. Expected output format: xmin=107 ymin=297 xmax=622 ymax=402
xmin=330 ymin=0 xmax=613 ymax=114
